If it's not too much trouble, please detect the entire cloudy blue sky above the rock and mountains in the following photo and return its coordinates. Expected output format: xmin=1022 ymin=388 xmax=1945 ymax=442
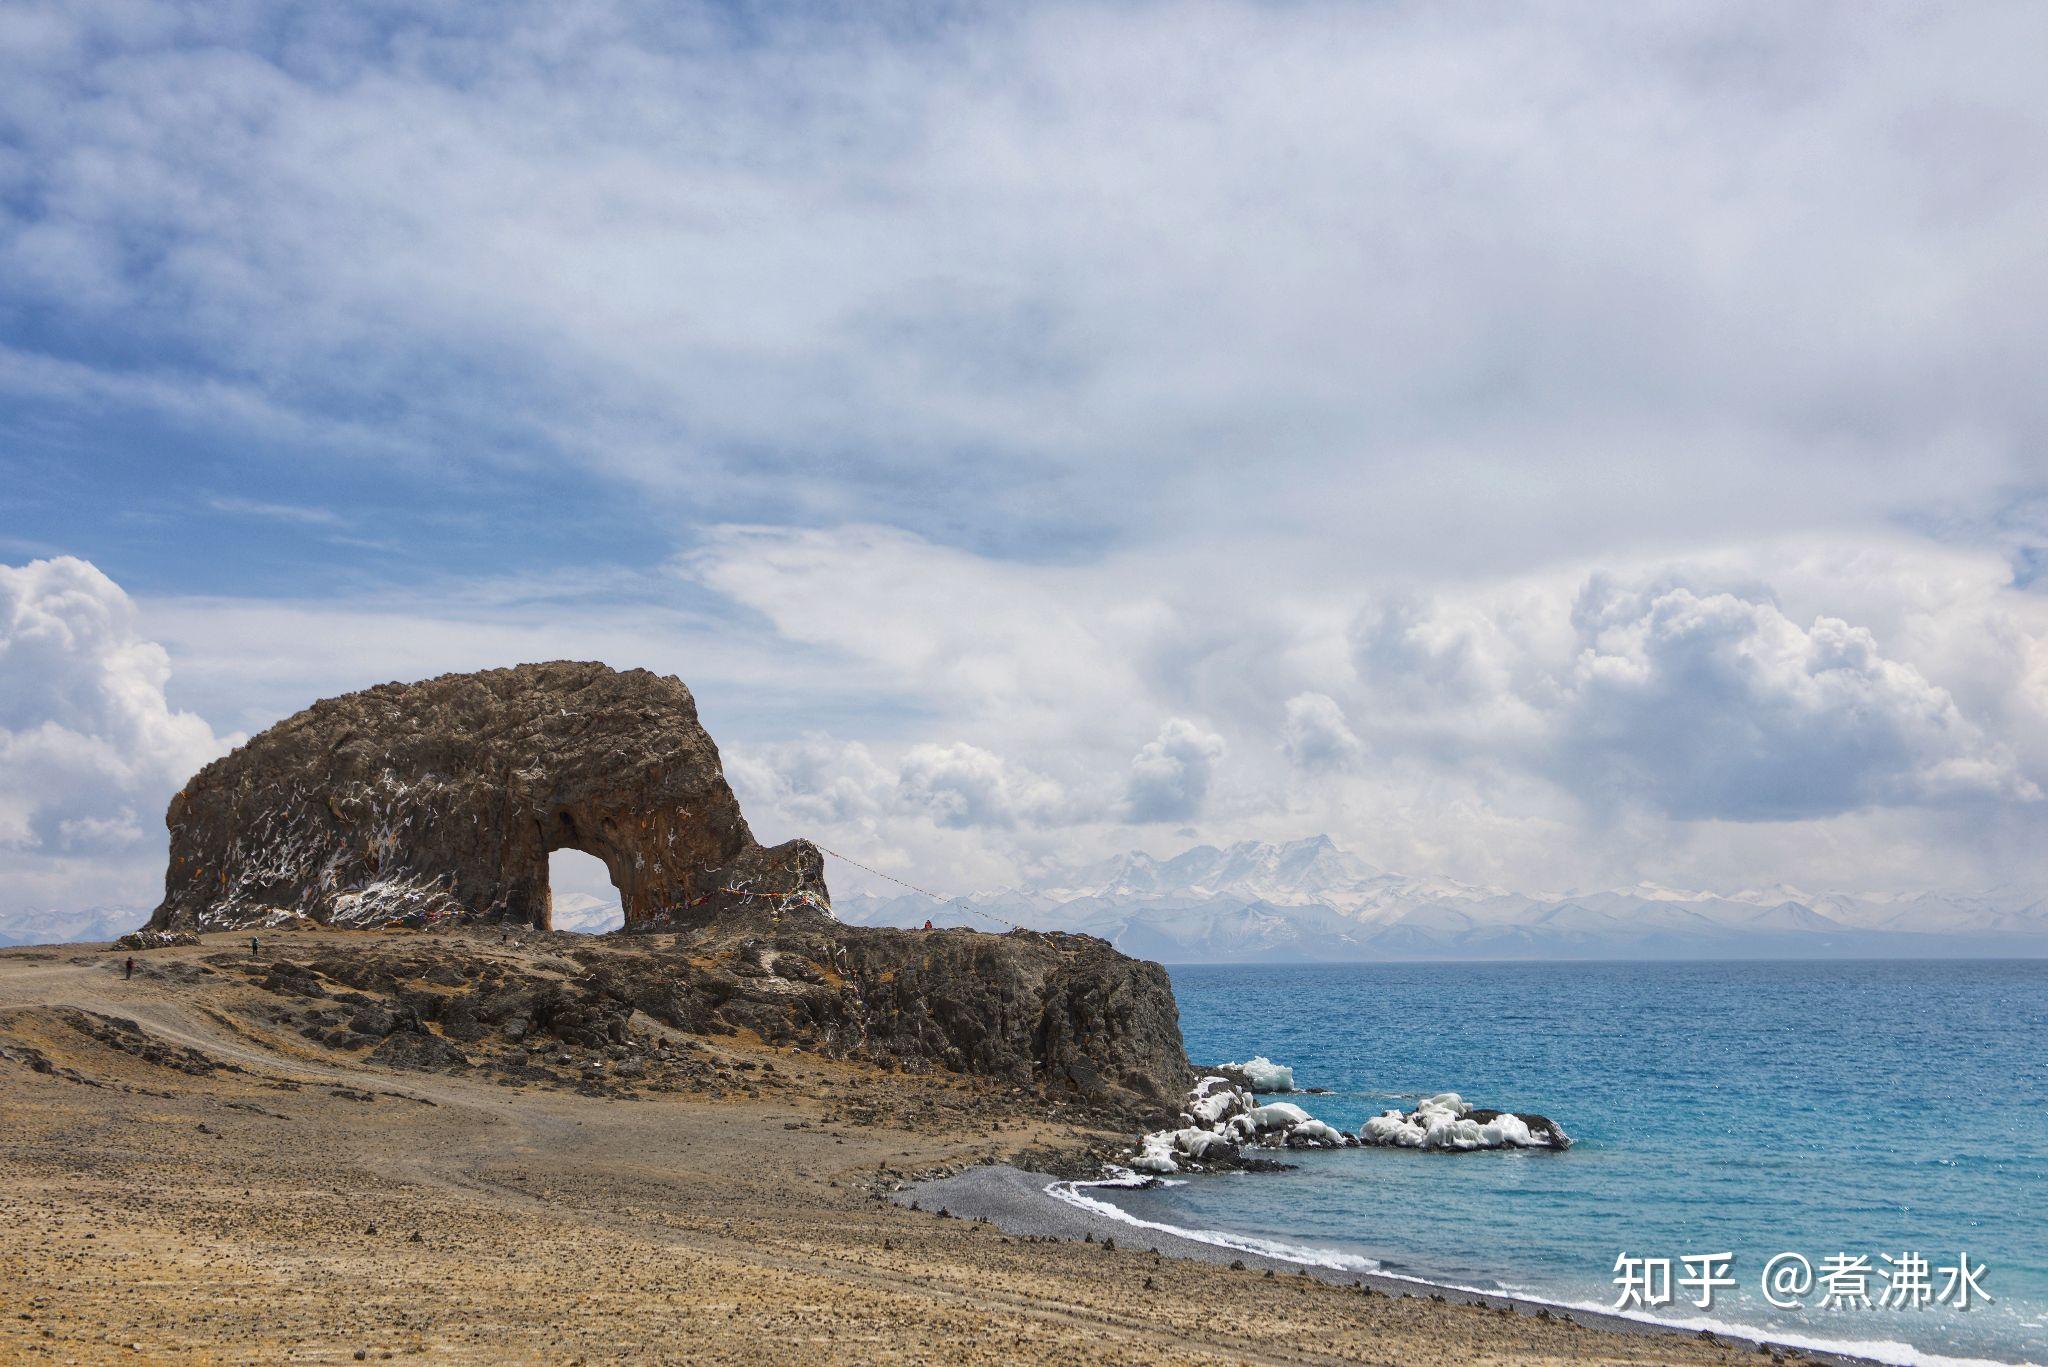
xmin=0 ymin=0 xmax=2048 ymax=918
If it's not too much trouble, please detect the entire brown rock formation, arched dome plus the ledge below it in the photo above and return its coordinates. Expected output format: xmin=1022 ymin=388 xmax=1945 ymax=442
xmin=145 ymin=662 xmax=1188 ymax=1117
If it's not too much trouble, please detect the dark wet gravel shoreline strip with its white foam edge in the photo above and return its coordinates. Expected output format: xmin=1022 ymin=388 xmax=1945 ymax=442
xmin=889 ymin=1164 xmax=1933 ymax=1367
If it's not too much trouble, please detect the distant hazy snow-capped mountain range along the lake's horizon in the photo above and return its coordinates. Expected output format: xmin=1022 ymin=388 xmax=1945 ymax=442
xmin=834 ymin=836 xmax=2048 ymax=963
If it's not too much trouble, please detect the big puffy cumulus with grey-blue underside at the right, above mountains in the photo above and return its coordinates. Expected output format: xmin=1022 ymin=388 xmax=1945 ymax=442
xmin=1352 ymin=551 xmax=2044 ymax=822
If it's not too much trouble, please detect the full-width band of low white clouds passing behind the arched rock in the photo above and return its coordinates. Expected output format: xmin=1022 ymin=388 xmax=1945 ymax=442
xmin=16 ymin=529 xmax=2048 ymax=930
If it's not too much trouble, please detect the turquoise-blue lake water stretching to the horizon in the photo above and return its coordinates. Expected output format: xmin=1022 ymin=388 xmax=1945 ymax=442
xmin=1092 ymin=961 xmax=2048 ymax=1361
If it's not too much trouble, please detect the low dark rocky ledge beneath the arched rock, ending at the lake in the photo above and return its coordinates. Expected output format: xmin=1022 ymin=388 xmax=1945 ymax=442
xmin=209 ymin=924 xmax=1188 ymax=1125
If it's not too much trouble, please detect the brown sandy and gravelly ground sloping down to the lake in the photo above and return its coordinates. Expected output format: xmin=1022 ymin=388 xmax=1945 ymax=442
xmin=0 ymin=935 xmax=1843 ymax=1363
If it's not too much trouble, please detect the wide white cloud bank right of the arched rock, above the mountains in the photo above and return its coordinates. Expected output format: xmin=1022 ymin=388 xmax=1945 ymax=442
xmin=675 ymin=529 xmax=2048 ymax=887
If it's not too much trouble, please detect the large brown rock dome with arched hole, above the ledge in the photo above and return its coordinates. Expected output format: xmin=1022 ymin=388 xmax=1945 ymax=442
xmin=150 ymin=662 xmax=827 ymax=930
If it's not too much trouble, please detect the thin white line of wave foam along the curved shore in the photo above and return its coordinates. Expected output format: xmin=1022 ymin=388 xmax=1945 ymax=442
xmin=1044 ymin=1172 xmax=2007 ymax=1367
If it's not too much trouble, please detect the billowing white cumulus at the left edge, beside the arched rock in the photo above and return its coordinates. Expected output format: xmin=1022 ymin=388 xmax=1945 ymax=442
xmin=0 ymin=557 xmax=231 ymax=910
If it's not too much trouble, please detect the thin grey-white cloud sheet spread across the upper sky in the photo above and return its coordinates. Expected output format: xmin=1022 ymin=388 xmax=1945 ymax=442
xmin=0 ymin=2 xmax=2048 ymax=572
